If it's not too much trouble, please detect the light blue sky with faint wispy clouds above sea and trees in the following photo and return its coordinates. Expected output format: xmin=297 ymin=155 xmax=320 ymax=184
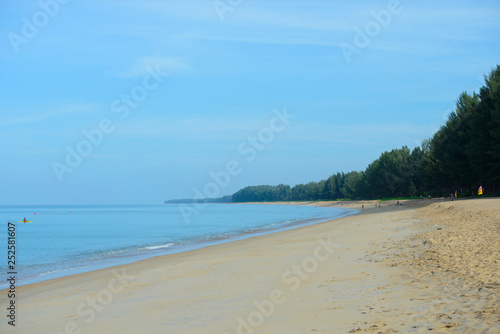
xmin=0 ymin=0 xmax=500 ymax=205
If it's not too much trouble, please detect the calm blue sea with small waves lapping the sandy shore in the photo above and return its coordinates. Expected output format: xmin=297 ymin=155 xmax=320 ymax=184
xmin=0 ymin=204 xmax=358 ymax=289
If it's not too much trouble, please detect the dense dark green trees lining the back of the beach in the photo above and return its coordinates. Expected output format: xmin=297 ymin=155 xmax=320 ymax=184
xmin=233 ymin=65 xmax=500 ymax=202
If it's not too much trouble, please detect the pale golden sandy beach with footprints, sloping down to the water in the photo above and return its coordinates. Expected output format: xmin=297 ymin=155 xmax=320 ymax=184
xmin=0 ymin=199 xmax=500 ymax=334
